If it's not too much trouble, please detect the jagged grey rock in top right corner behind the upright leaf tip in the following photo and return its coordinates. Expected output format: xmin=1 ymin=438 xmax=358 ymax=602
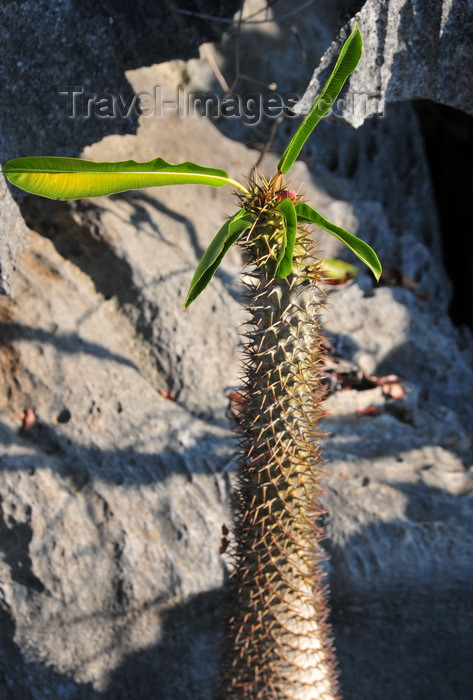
xmin=300 ymin=0 xmax=473 ymax=126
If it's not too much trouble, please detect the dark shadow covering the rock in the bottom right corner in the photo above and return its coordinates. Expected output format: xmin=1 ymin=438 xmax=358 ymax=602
xmin=327 ymin=484 xmax=473 ymax=700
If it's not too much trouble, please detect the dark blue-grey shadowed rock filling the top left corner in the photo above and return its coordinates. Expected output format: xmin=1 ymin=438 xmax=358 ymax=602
xmin=0 ymin=0 xmax=239 ymax=294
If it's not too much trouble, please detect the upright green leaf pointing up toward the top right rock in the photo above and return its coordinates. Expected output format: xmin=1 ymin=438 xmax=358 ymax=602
xmin=278 ymin=24 xmax=363 ymax=174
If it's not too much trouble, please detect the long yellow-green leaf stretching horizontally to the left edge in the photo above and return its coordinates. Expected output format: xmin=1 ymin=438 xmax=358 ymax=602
xmin=3 ymin=156 xmax=244 ymax=199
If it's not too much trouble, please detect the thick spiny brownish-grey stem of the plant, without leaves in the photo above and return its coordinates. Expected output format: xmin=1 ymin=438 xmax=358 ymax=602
xmin=219 ymin=202 xmax=337 ymax=700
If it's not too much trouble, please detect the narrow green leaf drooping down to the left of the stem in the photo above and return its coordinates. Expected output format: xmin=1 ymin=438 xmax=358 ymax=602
xmin=184 ymin=208 xmax=254 ymax=309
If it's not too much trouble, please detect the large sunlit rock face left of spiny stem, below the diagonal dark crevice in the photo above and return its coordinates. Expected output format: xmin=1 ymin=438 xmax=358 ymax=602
xmin=0 ymin=223 xmax=235 ymax=698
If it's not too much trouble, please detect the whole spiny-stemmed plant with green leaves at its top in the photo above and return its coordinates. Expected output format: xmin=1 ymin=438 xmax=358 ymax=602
xmin=3 ymin=25 xmax=381 ymax=700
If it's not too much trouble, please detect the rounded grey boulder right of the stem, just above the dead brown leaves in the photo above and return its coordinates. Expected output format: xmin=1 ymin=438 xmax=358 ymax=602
xmin=327 ymin=285 xmax=473 ymax=444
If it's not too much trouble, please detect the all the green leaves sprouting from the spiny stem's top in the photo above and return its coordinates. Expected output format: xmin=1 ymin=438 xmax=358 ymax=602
xmin=3 ymin=25 xmax=381 ymax=307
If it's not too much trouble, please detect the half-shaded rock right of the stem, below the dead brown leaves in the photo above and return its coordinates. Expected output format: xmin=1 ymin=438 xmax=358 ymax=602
xmin=326 ymin=442 xmax=473 ymax=700
